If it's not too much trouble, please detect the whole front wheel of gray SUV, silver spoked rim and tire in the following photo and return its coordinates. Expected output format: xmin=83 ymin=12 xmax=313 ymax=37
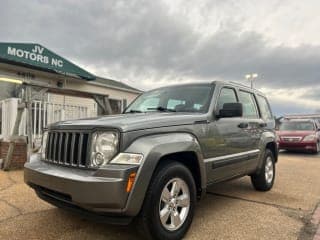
xmin=138 ymin=162 xmax=196 ymax=240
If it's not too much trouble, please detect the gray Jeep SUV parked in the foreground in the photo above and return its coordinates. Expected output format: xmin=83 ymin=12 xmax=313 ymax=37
xmin=24 ymin=81 xmax=278 ymax=240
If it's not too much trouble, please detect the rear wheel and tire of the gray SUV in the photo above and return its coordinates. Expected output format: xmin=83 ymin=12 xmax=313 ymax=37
xmin=251 ymin=149 xmax=276 ymax=191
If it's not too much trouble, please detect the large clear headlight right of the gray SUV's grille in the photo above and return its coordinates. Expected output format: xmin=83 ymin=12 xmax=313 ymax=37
xmin=91 ymin=132 xmax=119 ymax=167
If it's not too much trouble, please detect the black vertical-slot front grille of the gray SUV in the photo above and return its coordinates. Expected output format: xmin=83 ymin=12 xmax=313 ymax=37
xmin=45 ymin=131 xmax=90 ymax=167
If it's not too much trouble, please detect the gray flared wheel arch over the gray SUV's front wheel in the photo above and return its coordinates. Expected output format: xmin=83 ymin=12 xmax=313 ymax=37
xmin=123 ymin=133 xmax=206 ymax=216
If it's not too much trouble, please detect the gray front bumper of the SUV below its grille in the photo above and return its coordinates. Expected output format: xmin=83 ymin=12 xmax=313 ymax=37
xmin=24 ymin=156 xmax=138 ymax=218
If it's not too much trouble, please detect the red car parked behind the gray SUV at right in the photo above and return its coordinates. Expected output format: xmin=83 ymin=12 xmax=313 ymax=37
xmin=277 ymin=119 xmax=320 ymax=153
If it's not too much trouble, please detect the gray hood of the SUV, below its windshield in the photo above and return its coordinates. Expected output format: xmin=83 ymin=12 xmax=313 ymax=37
xmin=49 ymin=112 xmax=207 ymax=132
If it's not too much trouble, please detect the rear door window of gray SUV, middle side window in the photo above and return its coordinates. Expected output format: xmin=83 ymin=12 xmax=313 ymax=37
xmin=239 ymin=90 xmax=259 ymax=118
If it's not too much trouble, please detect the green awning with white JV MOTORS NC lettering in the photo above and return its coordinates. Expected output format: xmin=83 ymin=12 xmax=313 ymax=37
xmin=0 ymin=43 xmax=96 ymax=80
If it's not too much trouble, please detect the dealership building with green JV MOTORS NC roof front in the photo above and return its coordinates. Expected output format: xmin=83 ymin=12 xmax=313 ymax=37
xmin=0 ymin=43 xmax=141 ymax=169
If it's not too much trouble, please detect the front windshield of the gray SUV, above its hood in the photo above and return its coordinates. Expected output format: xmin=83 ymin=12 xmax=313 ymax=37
xmin=125 ymin=84 xmax=214 ymax=113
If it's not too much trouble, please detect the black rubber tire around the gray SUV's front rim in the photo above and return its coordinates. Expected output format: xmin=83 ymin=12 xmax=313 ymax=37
xmin=136 ymin=162 xmax=196 ymax=240
